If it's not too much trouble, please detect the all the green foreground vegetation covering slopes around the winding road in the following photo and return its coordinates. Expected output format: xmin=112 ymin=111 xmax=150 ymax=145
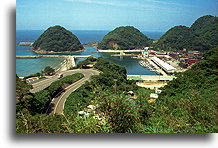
xmin=16 ymin=48 xmax=218 ymax=133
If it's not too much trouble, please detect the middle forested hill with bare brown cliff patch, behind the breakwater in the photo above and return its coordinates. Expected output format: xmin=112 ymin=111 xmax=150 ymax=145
xmin=98 ymin=26 xmax=151 ymax=50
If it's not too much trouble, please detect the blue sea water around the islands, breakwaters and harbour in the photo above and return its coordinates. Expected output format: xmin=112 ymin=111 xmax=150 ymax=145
xmin=16 ymin=30 xmax=164 ymax=77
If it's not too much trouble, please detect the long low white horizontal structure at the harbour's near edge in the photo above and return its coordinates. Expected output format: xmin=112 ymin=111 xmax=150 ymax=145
xmin=127 ymin=75 xmax=176 ymax=81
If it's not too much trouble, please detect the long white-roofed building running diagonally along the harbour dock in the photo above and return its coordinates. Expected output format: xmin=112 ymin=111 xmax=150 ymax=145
xmin=150 ymin=57 xmax=176 ymax=73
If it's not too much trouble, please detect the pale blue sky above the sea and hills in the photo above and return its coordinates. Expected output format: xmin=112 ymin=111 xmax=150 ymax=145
xmin=16 ymin=0 xmax=218 ymax=32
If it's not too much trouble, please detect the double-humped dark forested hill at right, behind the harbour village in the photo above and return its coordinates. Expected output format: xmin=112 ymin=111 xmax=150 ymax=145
xmin=155 ymin=15 xmax=218 ymax=50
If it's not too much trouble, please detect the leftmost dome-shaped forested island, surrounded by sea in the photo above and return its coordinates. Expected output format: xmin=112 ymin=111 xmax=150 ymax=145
xmin=33 ymin=26 xmax=83 ymax=52
